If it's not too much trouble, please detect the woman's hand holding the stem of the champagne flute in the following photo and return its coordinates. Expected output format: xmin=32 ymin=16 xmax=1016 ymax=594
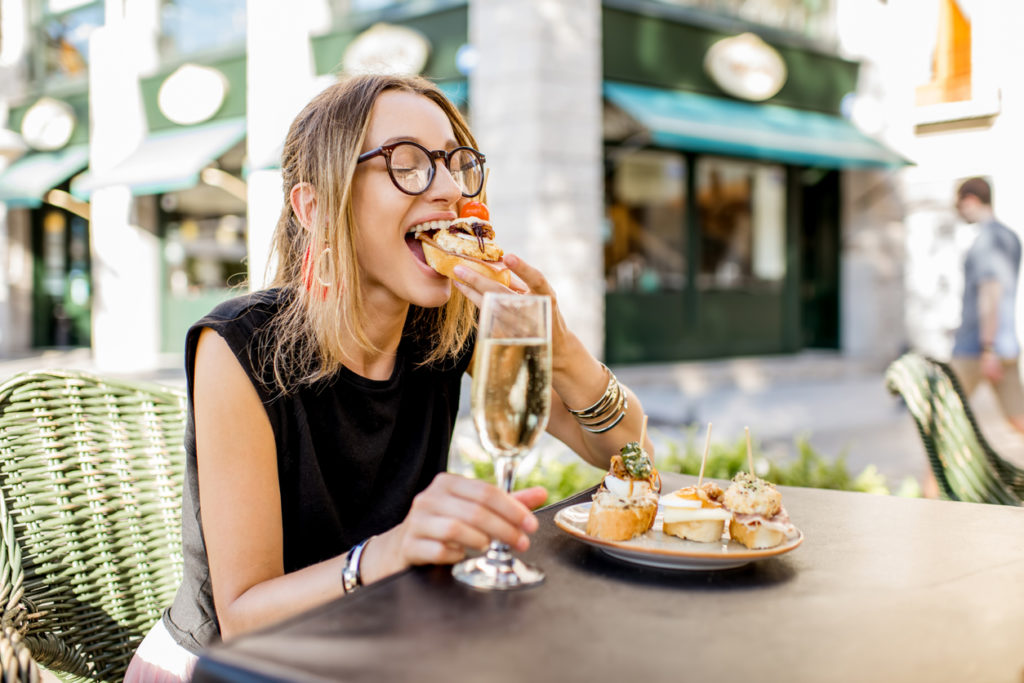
xmin=362 ymin=479 xmax=548 ymax=583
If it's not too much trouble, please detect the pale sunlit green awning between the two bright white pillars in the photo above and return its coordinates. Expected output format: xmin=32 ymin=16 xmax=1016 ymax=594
xmin=71 ymin=118 xmax=246 ymax=200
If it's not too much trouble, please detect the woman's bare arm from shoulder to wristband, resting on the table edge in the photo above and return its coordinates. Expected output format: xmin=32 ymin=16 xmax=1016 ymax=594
xmin=193 ymin=329 xmax=344 ymax=640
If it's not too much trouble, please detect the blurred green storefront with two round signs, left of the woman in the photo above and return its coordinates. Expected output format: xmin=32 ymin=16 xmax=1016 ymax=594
xmin=0 ymin=0 xmax=246 ymax=368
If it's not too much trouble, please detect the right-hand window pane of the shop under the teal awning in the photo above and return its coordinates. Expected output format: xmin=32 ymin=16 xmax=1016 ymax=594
xmin=696 ymin=157 xmax=785 ymax=290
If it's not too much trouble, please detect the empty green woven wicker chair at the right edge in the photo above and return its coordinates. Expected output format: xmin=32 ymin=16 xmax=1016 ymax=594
xmin=886 ymin=353 xmax=1024 ymax=505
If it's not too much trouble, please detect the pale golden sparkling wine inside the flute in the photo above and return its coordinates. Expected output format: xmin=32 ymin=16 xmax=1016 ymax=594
xmin=472 ymin=338 xmax=551 ymax=458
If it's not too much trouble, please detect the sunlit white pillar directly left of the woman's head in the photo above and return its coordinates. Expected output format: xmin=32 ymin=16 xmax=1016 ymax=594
xmin=246 ymin=0 xmax=324 ymax=290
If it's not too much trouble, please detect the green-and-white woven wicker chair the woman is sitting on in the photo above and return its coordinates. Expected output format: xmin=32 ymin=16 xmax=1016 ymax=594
xmin=0 ymin=372 xmax=185 ymax=681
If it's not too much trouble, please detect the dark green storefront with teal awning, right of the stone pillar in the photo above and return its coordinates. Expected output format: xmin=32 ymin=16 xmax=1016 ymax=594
xmin=602 ymin=2 xmax=903 ymax=362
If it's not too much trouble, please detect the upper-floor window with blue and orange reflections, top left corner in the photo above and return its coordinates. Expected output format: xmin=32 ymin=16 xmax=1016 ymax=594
xmin=34 ymin=0 xmax=103 ymax=80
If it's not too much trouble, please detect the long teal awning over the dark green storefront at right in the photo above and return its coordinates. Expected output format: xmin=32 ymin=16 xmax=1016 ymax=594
xmin=604 ymin=81 xmax=909 ymax=168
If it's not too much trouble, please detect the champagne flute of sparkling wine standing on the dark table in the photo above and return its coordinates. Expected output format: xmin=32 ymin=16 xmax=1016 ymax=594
xmin=452 ymin=292 xmax=551 ymax=591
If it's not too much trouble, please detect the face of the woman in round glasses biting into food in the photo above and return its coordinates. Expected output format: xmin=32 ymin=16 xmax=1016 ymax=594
xmin=352 ymin=90 xmax=463 ymax=310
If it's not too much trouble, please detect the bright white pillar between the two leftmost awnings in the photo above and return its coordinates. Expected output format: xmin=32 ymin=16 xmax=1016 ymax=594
xmin=89 ymin=0 xmax=161 ymax=373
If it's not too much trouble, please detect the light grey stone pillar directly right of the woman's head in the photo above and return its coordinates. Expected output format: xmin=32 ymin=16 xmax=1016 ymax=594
xmin=469 ymin=0 xmax=604 ymax=355
